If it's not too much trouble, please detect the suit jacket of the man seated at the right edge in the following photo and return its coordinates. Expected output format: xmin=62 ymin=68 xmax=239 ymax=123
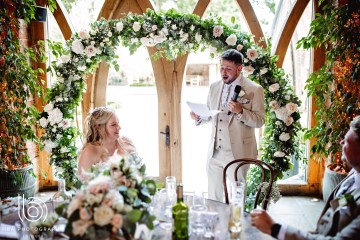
xmin=285 ymin=171 xmax=360 ymax=240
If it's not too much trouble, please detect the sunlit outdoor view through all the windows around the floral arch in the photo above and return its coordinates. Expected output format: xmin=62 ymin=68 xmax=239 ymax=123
xmin=48 ymin=0 xmax=313 ymax=192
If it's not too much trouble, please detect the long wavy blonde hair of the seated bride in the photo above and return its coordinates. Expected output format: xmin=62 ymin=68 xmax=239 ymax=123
xmin=85 ymin=107 xmax=115 ymax=143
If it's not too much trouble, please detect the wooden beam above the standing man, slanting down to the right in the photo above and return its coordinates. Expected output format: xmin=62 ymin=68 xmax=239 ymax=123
xmin=237 ymin=0 xmax=266 ymax=48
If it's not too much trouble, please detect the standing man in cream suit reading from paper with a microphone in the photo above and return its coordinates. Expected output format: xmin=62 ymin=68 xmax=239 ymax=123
xmin=190 ymin=49 xmax=265 ymax=201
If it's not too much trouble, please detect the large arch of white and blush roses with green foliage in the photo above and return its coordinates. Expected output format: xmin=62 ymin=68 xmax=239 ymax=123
xmin=39 ymin=9 xmax=301 ymax=188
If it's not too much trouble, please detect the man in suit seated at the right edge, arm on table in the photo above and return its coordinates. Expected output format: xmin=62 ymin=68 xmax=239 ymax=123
xmin=250 ymin=116 xmax=360 ymax=240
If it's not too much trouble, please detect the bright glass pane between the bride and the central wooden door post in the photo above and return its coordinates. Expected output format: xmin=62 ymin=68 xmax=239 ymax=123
xmin=106 ymin=47 xmax=159 ymax=177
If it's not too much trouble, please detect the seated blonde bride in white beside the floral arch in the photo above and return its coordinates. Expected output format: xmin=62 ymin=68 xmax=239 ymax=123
xmin=78 ymin=107 xmax=136 ymax=176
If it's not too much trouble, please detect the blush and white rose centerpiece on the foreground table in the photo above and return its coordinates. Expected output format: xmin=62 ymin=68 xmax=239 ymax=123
xmin=56 ymin=157 xmax=156 ymax=239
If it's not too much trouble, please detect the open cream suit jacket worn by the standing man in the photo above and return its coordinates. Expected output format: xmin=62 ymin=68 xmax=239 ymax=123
xmin=202 ymin=76 xmax=265 ymax=159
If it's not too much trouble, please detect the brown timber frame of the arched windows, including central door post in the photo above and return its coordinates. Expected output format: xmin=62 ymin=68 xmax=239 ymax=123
xmin=30 ymin=0 xmax=325 ymax=194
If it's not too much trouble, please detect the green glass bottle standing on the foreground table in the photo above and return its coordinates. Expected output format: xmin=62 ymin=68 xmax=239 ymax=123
xmin=172 ymin=184 xmax=189 ymax=240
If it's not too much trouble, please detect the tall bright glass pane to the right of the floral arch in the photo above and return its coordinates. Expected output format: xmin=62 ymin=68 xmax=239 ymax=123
xmin=279 ymin=1 xmax=313 ymax=184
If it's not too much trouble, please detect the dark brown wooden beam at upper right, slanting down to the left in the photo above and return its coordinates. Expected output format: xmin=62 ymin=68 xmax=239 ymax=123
xmin=274 ymin=0 xmax=309 ymax=67
